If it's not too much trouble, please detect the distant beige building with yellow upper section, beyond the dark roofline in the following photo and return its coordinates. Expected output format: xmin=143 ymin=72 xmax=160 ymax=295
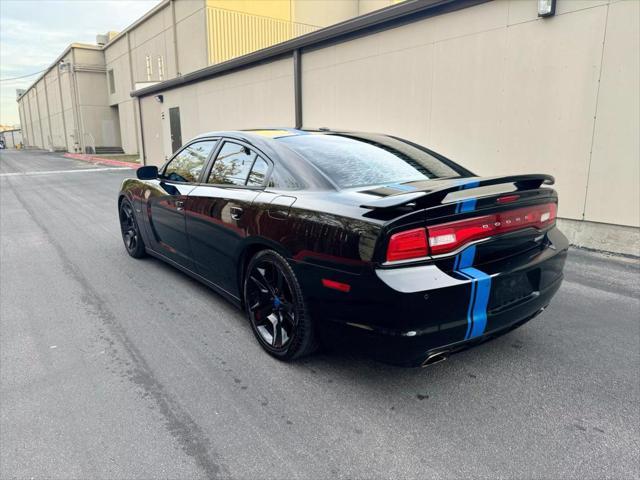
xmin=17 ymin=0 xmax=398 ymax=154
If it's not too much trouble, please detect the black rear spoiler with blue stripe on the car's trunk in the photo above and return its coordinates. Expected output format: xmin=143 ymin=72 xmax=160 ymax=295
xmin=360 ymin=174 xmax=555 ymax=210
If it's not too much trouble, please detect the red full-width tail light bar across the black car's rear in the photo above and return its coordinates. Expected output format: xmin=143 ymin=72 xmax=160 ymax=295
xmin=387 ymin=203 xmax=557 ymax=262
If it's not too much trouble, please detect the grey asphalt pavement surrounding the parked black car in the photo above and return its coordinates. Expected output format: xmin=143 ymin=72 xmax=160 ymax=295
xmin=0 ymin=151 xmax=640 ymax=479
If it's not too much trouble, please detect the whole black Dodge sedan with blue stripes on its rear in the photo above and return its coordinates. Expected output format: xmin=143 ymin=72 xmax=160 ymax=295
xmin=118 ymin=129 xmax=568 ymax=365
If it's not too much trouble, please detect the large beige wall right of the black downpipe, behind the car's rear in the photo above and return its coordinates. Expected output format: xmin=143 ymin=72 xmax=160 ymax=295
xmin=302 ymin=0 xmax=640 ymax=232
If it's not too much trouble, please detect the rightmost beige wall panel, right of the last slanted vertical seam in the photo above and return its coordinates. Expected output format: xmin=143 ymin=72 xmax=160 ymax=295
xmin=585 ymin=1 xmax=640 ymax=225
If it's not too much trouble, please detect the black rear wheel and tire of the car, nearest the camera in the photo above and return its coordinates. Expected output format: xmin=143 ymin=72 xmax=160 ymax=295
xmin=243 ymin=250 xmax=318 ymax=361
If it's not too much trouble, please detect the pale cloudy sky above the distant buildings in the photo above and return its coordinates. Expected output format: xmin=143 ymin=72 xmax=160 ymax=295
xmin=0 ymin=0 xmax=160 ymax=125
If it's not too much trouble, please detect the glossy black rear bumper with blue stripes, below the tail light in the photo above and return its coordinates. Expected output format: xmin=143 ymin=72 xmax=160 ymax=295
xmin=298 ymin=228 xmax=568 ymax=365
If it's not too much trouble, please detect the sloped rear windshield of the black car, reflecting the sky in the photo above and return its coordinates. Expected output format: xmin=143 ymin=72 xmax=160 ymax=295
xmin=279 ymin=134 xmax=460 ymax=188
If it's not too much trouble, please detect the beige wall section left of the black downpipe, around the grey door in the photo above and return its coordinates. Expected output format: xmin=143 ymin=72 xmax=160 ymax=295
xmin=140 ymin=58 xmax=294 ymax=165
